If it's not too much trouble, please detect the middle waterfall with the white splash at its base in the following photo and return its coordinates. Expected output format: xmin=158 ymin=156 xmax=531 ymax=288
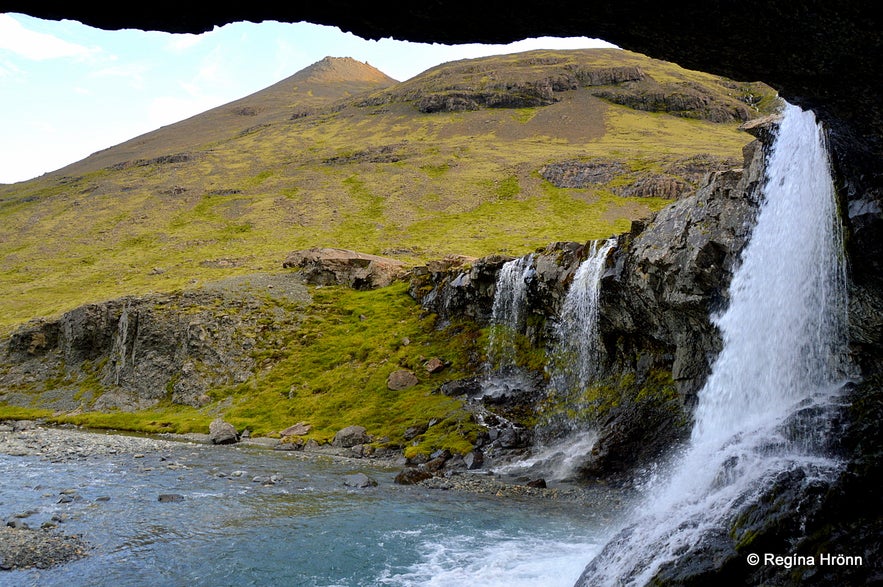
xmin=499 ymin=238 xmax=617 ymax=481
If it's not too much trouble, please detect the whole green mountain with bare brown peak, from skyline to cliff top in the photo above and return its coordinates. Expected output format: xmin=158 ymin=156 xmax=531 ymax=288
xmin=0 ymin=50 xmax=774 ymax=330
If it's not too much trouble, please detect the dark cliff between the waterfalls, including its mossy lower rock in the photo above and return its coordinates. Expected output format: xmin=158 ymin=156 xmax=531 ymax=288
xmin=410 ymin=125 xmax=774 ymax=477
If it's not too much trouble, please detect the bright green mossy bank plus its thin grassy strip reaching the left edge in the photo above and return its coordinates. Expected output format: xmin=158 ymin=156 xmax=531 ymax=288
xmin=0 ymin=282 xmax=484 ymax=456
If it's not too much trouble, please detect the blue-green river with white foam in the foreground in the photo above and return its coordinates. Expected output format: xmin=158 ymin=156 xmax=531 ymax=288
xmin=0 ymin=434 xmax=616 ymax=587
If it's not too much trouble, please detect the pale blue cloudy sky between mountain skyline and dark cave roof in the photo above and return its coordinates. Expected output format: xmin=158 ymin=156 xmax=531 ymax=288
xmin=0 ymin=13 xmax=613 ymax=183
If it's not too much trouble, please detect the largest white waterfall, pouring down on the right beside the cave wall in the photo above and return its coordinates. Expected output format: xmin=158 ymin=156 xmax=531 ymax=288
xmin=578 ymin=105 xmax=846 ymax=587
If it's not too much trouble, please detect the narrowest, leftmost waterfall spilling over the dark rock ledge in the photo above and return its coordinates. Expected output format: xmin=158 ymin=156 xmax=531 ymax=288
xmin=488 ymin=254 xmax=534 ymax=371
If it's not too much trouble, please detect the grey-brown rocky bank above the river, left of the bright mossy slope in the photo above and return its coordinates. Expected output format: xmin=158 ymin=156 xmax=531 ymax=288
xmin=0 ymin=278 xmax=309 ymax=411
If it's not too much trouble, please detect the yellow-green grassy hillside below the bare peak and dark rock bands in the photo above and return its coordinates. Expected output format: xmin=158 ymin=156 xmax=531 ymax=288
xmin=0 ymin=51 xmax=772 ymax=329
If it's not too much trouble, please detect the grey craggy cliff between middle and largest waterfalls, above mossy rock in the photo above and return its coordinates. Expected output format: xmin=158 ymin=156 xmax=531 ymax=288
xmin=600 ymin=137 xmax=763 ymax=405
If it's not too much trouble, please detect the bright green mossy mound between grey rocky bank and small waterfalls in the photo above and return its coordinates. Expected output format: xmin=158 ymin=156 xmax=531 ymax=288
xmin=212 ymin=283 xmax=481 ymax=453
